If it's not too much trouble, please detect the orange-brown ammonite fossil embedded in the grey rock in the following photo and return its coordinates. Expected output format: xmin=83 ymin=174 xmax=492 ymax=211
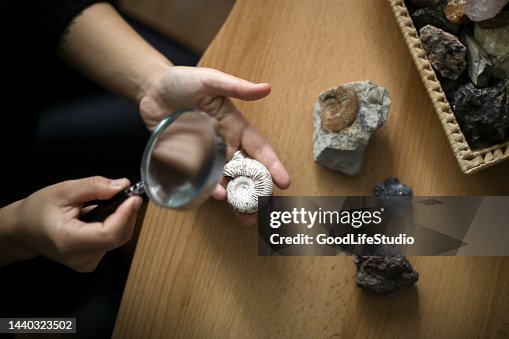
xmin=320 ymin=86 xmax=358 ymax=133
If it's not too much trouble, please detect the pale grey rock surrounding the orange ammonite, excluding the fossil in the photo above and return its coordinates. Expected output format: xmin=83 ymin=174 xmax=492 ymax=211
xmin=313 ymin=81 xmax=391 ymax=175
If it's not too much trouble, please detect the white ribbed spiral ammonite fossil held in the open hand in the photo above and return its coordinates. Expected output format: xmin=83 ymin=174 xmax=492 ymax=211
xmin=223 ymin=151 xmax=273 ymax=213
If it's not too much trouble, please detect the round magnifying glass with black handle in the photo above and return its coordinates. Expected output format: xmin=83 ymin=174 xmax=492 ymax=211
xmin=80 ymin=109 xmax=226 ymax=222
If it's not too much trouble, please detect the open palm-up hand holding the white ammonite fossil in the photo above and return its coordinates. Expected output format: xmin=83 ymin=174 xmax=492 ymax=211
xmin=140 ymin=66 xmax=290 ymax=224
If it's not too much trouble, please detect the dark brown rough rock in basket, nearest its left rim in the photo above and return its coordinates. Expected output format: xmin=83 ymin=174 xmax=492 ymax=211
xmin=419 ymin=25 xmax=467 ymax=79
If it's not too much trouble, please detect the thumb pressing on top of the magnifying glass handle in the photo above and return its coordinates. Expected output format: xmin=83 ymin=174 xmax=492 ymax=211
xmin=60 ymin=176 xmax=130 ymax=202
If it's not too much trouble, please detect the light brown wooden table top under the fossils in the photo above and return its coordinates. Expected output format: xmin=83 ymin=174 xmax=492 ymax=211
xmin=114 ymin=0 xmax=509 ymax=338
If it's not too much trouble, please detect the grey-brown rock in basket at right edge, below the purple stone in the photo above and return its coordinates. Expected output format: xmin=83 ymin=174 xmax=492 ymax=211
xmin=474 ymin=12 xmax=509 ymax=79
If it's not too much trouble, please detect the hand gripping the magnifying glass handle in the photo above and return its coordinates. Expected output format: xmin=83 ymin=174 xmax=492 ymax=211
xmin=0 ymin=177 xmax=142 ymax=272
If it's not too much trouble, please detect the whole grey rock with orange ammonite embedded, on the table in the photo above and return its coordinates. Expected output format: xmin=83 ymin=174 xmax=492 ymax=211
xmin=313 ymin=81 xmax=390 ymax=175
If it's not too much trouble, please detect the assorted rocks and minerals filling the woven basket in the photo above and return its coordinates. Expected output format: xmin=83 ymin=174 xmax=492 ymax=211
xmin=405 ymin=0 xmax=509 ymax=149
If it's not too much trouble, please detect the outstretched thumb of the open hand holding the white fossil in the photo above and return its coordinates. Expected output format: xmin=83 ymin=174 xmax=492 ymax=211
xmin=203 ymin=68 xmax=271 ymax=101
